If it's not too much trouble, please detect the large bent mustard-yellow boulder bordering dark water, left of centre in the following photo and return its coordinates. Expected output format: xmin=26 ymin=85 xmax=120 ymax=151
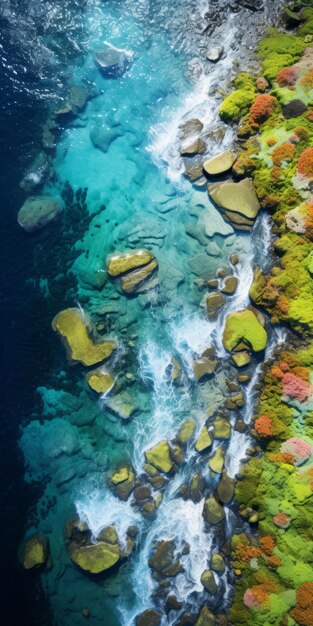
xmin=52 ymin=307 xmax=117 ymax=365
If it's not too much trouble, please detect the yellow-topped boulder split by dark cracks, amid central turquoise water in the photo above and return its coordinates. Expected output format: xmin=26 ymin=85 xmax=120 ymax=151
xmin=106 ymin=248 xmax=158 ymax=295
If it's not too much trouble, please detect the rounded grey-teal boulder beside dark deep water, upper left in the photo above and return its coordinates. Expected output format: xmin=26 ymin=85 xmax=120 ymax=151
xmin=17 ymin=196 xmax=63 ymax=233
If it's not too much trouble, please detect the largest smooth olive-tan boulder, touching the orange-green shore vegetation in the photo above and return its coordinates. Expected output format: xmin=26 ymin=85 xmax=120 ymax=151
xmin=208 ymin=178 xmax=261 ymax=230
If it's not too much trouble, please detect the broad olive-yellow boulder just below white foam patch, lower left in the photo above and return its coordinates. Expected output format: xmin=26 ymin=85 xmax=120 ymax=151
xmin=68 ymin=541 xmax=120 ymax=574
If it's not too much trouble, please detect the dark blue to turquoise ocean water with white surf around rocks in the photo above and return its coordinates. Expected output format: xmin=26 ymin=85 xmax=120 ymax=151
xmin=0 ymin=0 xmax=283 ymax=626
